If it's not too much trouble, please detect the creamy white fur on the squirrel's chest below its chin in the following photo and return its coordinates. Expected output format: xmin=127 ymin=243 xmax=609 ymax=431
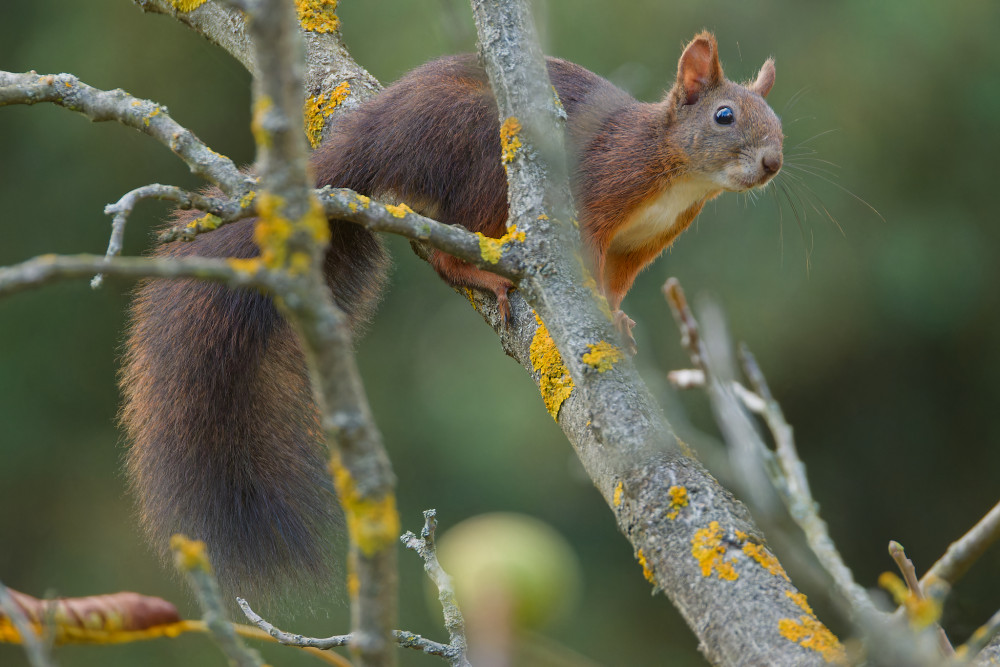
xmin=610 ymin=179 xmax=719 ymax=253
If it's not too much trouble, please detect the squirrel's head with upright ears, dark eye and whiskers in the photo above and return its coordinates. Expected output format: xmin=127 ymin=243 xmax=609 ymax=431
xmin=664 ymin=32 xmax=784 ymax=191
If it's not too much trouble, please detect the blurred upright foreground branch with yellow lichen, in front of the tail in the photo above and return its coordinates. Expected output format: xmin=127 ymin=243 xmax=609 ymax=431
xmin=236 ymin=0 xmax=399 ymax=666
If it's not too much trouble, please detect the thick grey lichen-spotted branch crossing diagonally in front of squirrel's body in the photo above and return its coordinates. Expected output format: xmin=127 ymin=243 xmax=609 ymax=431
xmin=472 ymin=0 xmax=843 ymax=665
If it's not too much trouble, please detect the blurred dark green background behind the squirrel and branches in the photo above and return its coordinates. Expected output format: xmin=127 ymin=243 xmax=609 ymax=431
xmin=0 ymin=0 xmax=1000 ymax=665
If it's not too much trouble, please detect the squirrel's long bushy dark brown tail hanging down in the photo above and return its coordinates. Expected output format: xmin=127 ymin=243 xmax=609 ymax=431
xmin=121 ymin=214 xmax=387 ymax=596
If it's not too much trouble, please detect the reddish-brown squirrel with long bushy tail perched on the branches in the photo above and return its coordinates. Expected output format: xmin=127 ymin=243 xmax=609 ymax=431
xmin=121 ymin=32 xmax=782 ymax=595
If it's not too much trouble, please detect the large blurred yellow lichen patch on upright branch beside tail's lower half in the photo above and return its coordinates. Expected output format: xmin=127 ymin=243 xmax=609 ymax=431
xmin=330 ymin=454 xmax=399 ymax=556
